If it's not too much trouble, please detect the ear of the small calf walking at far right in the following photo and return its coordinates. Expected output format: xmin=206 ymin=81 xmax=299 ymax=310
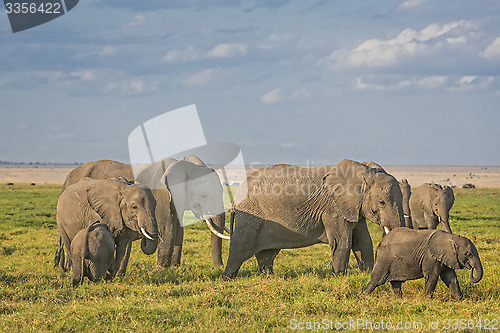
xmin=427 ymin=230 xmax=460 ymax=269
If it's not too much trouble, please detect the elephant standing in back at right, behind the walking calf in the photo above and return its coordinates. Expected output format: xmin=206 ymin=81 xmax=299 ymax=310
xmin=410 ymin=183 xmax=455 ymax=233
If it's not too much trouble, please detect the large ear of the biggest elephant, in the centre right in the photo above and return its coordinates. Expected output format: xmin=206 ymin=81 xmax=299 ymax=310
xmin=323 ymin=160 xmax=370 ymax=222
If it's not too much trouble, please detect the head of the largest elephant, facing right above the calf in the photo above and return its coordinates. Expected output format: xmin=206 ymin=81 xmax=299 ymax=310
xmin=323 ymin=160 xmax=404 ymax=233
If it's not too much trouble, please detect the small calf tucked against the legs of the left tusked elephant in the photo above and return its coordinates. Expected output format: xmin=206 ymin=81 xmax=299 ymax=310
xmin=71 ymin=221 xmax=115 ymax=288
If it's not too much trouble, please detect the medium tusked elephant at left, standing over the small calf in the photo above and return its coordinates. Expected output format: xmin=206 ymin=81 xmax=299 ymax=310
xmin=54 ymin=178 xmax=158 ymax=278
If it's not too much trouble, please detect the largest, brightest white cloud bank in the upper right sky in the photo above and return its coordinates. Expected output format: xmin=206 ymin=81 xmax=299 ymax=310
xmin=319 ymin=20 xmax=476 ymax=70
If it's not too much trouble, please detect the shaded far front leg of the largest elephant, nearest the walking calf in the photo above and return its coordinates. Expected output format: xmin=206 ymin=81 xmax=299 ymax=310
xmin=352 ymin=218 xmax=374 ymax=271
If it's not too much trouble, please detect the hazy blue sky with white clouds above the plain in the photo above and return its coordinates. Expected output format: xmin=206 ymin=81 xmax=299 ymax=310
xmin=0 ymin=0 xmax=500 ymax=165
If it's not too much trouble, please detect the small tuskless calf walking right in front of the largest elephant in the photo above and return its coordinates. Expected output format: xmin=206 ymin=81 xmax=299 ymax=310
xmin=363 ymin=228 xmax=483 ymax=300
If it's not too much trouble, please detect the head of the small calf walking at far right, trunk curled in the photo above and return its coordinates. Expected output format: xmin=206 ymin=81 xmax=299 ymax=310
xmin=428 ymin=230 xmax=483 ymax=283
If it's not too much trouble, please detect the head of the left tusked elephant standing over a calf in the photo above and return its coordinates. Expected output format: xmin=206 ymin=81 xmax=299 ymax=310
xmin=87 ymin=178 xmax=158 ymax=255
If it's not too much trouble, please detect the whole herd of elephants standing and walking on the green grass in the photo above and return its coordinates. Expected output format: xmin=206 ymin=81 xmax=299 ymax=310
xmin=55 ymin=155 xmax=483 ymax=300
